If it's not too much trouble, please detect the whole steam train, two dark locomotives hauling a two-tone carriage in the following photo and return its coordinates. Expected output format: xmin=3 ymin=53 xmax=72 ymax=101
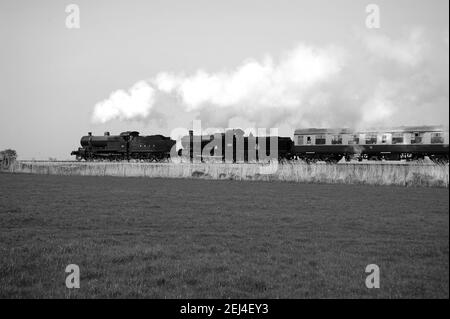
xmin=71 ymin=126 xmax=449 ymax=163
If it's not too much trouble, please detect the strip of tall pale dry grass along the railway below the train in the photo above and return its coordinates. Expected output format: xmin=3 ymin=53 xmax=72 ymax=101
xmin=5 ymin=162 xmax=449 ymax=187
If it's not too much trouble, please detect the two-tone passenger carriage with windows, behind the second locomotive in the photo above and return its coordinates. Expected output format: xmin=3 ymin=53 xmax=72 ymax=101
xmin=293 ymin=126 xmax=449 ymax=162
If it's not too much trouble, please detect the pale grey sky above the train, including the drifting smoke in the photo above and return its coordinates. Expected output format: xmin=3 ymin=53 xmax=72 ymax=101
xmin=0 ymin=0 xmax=449 ymax=159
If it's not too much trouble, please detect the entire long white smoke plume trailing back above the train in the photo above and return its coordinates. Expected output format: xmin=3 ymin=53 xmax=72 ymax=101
xmin=93 ymin=28 xmax=449 ymax=128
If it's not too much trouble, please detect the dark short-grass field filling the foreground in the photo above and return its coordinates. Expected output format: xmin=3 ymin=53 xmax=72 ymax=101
xmin=0 ymin=173 xmax=449 ymax=298
